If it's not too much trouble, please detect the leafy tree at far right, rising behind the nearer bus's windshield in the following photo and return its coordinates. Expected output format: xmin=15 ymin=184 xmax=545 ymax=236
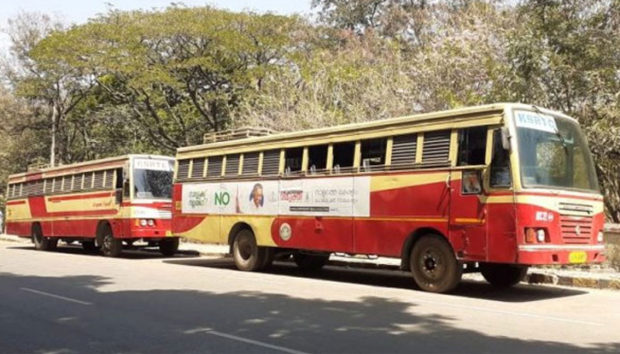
xmin=505 ymin=0 xmax=620 ymax=222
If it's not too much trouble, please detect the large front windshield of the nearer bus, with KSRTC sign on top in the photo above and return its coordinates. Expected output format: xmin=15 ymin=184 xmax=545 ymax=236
xmin=515 ymin=111 xmax=598 ymax=192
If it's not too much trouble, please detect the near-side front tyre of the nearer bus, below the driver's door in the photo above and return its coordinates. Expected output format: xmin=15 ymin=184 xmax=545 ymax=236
xmin=409 ymin=235 xmax=463 ymax=293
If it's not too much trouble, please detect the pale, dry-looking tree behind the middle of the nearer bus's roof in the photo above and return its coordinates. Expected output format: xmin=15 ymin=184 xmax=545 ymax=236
xmin=235 ymin=28 xmax=413 ymax=131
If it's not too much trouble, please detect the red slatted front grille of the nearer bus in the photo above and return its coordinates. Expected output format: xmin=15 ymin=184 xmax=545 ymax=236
xmin=559 ymin=203 xmax=594 ymax=244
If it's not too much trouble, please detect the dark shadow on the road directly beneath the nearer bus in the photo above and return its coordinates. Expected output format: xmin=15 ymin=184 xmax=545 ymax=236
xmin=164 ymin=258 xmax=587 ymax=302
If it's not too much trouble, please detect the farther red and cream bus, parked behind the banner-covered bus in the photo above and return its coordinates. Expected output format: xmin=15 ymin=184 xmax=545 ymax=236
xmin=6 ymin=155 xmax=179 ymax=257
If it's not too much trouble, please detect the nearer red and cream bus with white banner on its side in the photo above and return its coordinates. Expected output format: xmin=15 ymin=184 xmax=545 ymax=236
xmin=172 ymin=104 xmax=604 ymax=292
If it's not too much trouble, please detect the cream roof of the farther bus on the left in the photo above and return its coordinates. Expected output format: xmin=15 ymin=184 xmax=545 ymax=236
xmin=9 ymin=154 xmax=174 ymax=183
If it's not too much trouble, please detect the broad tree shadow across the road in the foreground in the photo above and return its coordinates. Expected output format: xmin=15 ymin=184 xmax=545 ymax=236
xmin=0 ymin=267 xmax=620 ymax=353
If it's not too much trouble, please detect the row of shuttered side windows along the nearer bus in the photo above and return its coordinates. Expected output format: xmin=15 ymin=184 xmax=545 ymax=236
xmin=176 ymin=126 xmax=488 ymax=180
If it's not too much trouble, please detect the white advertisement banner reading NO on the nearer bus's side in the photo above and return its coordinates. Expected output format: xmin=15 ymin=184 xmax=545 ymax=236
xmin=182 ymin=176 xmax=370 ymax=216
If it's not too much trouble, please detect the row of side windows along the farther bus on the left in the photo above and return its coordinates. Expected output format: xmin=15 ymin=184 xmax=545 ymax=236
xmin=7 ymin=169 xmax=120 ymax=199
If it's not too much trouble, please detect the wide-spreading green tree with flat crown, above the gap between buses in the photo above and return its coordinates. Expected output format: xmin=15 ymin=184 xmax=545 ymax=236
xmin=44 ymin=7 xmax=302 ymax=152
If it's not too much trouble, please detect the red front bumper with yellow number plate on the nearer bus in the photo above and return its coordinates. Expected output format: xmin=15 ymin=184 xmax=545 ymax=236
xmin=517 ymin=245 xmax=605 ymax=265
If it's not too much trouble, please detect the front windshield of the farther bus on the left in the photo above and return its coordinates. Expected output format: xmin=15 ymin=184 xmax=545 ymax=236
xmin=133 ymin=160 xmax=173 ymax=199
